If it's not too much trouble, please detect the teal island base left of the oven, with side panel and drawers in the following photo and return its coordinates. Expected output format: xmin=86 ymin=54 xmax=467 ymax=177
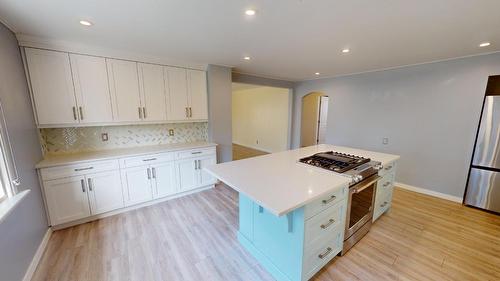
xmin=238 ymin=186 xmax=348 ymax=281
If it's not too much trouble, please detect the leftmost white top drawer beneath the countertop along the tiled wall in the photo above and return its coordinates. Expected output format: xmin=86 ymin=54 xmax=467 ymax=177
xmin=40 ymin=160 xmax=119 ymax=180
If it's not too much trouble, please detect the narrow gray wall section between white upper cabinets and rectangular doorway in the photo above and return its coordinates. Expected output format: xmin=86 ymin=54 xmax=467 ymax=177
xmin=207 ymin=65 xmax=233 ymax=163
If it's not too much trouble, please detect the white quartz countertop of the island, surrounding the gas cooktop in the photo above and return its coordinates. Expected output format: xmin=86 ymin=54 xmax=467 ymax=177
xmin=205 ymin=144 xmax=399 ymax=216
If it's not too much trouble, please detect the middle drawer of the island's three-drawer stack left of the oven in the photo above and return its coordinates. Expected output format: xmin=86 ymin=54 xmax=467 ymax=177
xmin=304 ymin=200 xmax=346 ymax=247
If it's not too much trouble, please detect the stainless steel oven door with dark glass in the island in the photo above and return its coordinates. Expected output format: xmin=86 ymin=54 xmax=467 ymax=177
xmin=344 ymin=174 xmax=380 ymax=237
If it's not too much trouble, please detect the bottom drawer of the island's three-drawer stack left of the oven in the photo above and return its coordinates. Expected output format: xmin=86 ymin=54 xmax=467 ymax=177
xmin=302 ymin=227 xmax=344 ymax=280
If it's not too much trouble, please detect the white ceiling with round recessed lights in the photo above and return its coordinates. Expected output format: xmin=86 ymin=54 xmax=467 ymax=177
xmin=0 ymin=0 xmax=500 ymax=80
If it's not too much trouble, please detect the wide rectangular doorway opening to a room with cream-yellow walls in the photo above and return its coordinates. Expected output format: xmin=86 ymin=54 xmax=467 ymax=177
xmin=232 ymin=83 xmax=292 ymax=160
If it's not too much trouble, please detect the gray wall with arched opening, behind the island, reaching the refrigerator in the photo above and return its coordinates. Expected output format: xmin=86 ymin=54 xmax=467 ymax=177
xmin=292 ymin=53 xmax=500 ymax=197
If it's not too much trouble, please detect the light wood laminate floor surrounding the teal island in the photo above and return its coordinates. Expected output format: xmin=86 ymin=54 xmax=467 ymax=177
xmin=33 ymin=185 xmax=500 ymax=281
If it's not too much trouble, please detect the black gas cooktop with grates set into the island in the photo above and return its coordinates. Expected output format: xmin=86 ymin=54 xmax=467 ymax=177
xmin=299 ymin=151 xmax=370 ymax=173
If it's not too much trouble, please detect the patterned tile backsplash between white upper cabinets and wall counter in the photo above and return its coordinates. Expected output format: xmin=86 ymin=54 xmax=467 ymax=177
xmin=40 ymin=122 xmax=208 ymax=154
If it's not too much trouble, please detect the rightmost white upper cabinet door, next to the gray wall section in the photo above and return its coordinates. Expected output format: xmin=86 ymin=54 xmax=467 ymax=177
xmin=187 ymin=70 xmax=208 ymax=120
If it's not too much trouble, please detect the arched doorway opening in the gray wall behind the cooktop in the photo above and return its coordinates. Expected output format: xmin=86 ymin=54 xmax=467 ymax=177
xmin=300 ymin=92 xmax=328 ymax=147
